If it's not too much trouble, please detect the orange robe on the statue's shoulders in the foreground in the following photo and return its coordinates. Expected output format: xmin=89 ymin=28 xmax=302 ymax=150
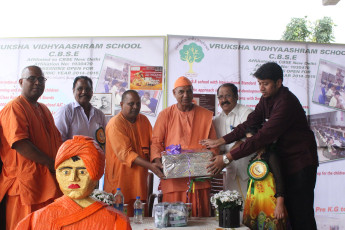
xmin=16 ymin=196 xmax=132 ymax=230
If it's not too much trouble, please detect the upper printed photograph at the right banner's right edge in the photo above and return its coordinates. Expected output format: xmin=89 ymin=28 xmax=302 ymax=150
xmin=313 ymin=60 xmax=345 ymax=111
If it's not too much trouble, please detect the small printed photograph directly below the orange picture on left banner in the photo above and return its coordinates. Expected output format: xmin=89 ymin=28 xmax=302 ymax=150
xmin=137 ymin=90 xmax=162 ymax=117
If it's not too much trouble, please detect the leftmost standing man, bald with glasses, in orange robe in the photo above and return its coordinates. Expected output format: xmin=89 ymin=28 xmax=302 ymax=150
xmin=0 ymin=66 xmax=62 ymax=230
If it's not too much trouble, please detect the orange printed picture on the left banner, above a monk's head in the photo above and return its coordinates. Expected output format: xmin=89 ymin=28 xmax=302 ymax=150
xmin=129 ymin=66 xmax=163 ymax=90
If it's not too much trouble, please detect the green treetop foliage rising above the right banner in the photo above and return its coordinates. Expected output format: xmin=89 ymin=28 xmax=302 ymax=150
xmin=282 ymin=16 xmax=336 ymax=43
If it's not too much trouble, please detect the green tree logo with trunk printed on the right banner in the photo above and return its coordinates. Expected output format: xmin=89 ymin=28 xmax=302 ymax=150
xmin=180 ymin=43 xmax=205 ymax=73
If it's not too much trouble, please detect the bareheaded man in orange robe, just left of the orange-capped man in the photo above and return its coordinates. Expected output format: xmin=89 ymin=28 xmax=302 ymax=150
xmin=104 ymin=90 xmax=164 ymax=216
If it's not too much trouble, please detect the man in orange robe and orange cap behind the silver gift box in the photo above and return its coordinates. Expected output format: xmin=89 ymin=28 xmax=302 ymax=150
xmin=151 ymin=77 xmax=218 ymax=216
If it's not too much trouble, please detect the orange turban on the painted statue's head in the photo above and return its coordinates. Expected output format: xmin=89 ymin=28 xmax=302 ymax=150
xmin=55 ymin=136 xmax=105 ymax=180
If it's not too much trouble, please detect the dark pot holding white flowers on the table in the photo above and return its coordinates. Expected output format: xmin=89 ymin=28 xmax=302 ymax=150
xmin=218 ymin=208 xmax=240 ymax=228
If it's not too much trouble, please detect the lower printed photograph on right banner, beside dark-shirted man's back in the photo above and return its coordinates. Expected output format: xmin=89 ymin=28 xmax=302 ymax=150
xmin=308 ymin=111 xmax=345 ymax=163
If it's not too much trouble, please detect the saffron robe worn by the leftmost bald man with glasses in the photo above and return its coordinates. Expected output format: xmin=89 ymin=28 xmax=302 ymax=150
xmin=0 ymin=96 xmax=62 ymax=229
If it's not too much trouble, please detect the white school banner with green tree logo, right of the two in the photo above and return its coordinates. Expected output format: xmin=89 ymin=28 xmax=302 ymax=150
xmin=167 ymin=35 xmax=345 ymax=229
